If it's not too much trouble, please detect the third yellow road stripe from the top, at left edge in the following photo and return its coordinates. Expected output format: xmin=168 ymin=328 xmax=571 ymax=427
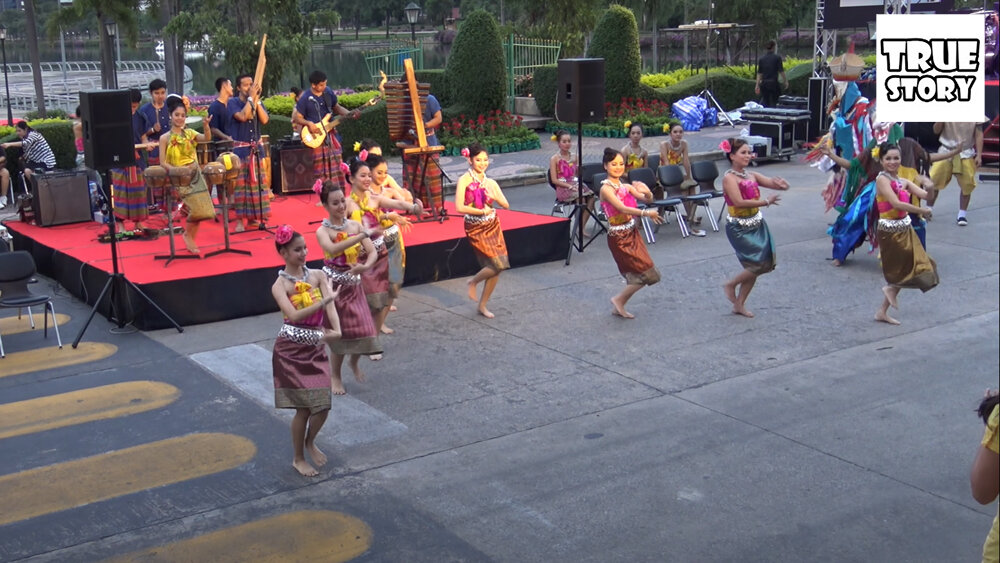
xmin=0 ymin=381 xmax=181 ymax=438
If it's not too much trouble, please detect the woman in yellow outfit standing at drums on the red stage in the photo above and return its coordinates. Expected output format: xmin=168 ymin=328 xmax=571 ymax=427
xmin=160 ymin=97 xmax=212 ymax=254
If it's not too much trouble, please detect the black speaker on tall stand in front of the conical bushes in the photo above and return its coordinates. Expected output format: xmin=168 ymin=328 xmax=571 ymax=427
xmin=556 ymin=59 xmax=604 ymax=123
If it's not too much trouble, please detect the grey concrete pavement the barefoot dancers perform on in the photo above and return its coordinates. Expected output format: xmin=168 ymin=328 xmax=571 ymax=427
xmin=0 ymin=132 xmax=1000 ymax=562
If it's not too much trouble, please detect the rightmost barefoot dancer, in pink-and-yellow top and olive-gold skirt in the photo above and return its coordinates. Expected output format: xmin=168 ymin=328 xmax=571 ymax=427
xmin=875 ymin=143 xmax=938 ymax=325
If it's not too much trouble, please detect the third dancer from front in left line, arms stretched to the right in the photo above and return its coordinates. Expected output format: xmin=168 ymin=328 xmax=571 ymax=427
xmin=344 ymin=154 xmax=423 ymax=332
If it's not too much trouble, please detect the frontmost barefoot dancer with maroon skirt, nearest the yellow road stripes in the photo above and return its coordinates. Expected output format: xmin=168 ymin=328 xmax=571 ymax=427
xmin=271 ymin=225 xmax=340 ymax=477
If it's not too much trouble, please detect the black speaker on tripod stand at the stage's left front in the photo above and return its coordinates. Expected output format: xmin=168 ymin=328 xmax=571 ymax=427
xmin=80 ymin=90 xmax=135 ymax=170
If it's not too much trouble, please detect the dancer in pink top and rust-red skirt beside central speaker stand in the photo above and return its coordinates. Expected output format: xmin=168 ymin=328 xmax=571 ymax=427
xmin=600 ymin=148 xmax=663 ymax=319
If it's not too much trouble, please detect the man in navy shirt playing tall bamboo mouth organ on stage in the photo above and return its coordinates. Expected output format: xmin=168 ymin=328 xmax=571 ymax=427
xmin=228 ymin=74 xmax=271 ymax=232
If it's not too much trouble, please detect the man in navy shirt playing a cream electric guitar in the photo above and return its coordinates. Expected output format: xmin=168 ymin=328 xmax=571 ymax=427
xmin=294 ymin=70 xmax=361 ymax=190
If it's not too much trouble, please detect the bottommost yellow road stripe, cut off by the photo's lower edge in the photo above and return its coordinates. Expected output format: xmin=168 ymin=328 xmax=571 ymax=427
xmin=106 ymin=510 xmax=372 ymax=563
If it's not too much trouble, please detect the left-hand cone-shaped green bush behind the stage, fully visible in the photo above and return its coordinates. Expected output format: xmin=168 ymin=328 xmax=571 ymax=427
xmin=446 ymin=10 xmax=507 ymax=115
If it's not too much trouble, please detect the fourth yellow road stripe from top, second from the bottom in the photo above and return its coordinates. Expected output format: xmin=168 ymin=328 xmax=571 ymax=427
xmin=0 ymin=433 xmax=257 ymax=526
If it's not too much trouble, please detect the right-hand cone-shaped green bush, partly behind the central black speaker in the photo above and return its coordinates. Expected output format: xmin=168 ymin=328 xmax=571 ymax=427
xmin=587 ymin=4 xmax=642 ymax=103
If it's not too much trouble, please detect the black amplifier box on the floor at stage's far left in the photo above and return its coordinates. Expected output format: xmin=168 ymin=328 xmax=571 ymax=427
xmin=31 ymin=170 xmax=94 ymax=227
